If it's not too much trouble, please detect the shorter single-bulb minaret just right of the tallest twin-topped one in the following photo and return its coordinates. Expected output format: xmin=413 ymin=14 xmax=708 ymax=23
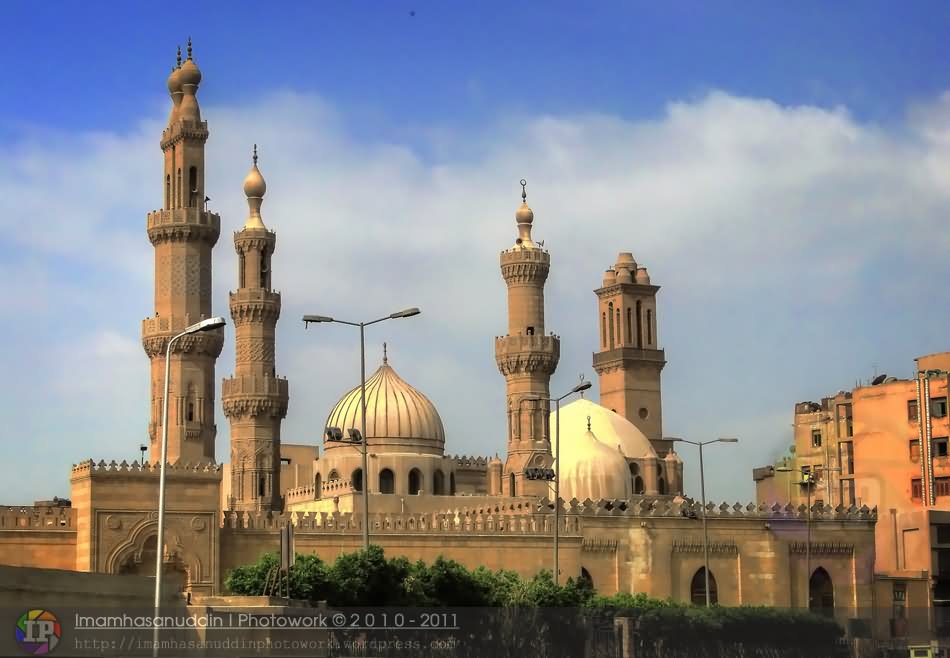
xmin=221 ymin=144 xmax=288 ymax=511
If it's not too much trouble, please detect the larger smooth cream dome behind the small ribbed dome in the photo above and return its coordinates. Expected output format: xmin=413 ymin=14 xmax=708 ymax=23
xmin=551 ymin=398 xmax=657 ymax=459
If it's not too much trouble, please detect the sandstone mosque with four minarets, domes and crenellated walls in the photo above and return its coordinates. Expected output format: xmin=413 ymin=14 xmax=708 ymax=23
xmin=0 ymin=41 xmax=877 ymax=621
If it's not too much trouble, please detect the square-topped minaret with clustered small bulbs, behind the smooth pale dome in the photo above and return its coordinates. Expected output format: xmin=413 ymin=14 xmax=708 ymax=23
xmin=594 ymin=252 xmax=672 ymax=456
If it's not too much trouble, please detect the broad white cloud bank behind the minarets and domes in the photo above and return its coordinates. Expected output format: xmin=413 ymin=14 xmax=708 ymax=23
xmin=0 ymin=83 xmax=950 ymax=502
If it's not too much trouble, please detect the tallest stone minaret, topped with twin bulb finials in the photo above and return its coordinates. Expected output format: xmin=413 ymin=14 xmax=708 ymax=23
xmin=142 ymin=39 xmax=224 ymax=463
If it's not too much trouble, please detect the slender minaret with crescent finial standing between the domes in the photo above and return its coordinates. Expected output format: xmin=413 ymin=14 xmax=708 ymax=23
xmin=495 ymin=180 xmax=561 ymax=497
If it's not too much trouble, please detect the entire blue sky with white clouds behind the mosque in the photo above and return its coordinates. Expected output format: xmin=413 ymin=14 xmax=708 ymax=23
xmin=0 ymin=2 xmax=950 ymax=504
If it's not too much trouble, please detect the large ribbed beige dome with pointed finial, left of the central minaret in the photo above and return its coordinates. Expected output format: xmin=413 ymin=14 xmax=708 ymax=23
xmin=325 ymin=356 xmax=445 ymax=454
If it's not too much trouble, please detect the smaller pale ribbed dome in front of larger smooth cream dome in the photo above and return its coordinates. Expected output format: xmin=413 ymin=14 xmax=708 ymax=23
xmin=557 ymin=422 xmax=631 ymax=500
